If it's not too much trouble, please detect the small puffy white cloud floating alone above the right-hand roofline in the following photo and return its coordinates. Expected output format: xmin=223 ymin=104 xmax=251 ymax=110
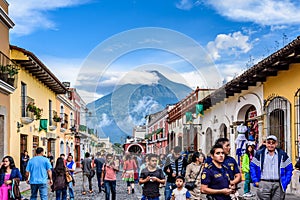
xmin=207 ymin=31 xmax=252 ymax=60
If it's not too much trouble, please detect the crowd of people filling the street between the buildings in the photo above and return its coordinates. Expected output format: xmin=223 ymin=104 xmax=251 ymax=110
xmin=0 ymin=135 xmax=300 ymax=200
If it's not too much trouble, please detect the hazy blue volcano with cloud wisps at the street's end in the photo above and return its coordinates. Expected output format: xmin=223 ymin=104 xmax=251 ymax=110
xmin=87 ymin=71 xmax=192 ymax=143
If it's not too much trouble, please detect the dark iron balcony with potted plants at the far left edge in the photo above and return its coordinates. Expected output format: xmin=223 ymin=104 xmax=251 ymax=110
xmin=0 ymin=51 xmax=20 ymax=88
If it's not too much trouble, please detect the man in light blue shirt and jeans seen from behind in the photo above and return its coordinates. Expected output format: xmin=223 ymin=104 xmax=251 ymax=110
xmin=26 ymin=147 xmax=53 ymax=200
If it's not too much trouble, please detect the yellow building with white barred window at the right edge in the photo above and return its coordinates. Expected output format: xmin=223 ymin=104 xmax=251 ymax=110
xmin=263 ymin=37 xmax=300 ymax=163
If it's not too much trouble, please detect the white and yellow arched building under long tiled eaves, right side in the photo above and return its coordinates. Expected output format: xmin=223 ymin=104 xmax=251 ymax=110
xmin=199 ymin=37 xmax=300 ymax=162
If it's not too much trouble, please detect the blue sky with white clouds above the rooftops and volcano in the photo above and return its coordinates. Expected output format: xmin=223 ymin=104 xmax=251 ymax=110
xmin=8 ymin=0 xmax=300 ymax=102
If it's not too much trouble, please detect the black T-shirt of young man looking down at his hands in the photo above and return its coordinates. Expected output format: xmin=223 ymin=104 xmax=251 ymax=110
xmin=140 ymin=167 xmax=165 ymax=198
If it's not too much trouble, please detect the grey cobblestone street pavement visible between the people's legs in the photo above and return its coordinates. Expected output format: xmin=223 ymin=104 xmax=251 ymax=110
xmin=20 ymin=169 xmax=300 ymax=200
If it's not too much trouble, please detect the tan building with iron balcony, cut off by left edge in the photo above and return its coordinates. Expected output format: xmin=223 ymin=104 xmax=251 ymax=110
xmin=0 ymin=0 xmax=14 ymax=159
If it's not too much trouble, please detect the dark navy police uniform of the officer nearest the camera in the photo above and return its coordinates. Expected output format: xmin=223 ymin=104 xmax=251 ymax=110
xmin=201 ymin=163 xmax=231 ymax=200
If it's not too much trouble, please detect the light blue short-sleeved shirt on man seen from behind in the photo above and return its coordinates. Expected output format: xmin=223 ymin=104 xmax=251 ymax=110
xmin=26 ymin=156 xmax=52 ymax=184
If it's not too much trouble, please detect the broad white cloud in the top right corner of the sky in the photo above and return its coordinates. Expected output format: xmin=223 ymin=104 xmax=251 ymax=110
xmin=202 ymin=0 xmax=300 ymax=25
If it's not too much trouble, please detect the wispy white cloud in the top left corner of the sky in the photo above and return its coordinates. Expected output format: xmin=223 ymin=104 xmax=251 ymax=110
xmin=9 ymin=0 xmax=91 ymax=35
